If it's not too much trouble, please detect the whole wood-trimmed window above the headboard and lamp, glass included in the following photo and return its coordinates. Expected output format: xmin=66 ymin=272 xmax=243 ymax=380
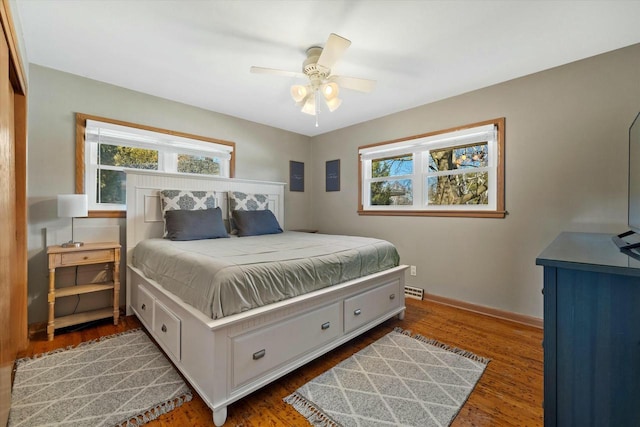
xmin=76 ymin=114 xmax=235 ymax=211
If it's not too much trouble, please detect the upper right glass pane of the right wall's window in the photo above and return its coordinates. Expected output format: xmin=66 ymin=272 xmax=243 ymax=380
xmin=429 ymin=142 xmax=489 ymax=172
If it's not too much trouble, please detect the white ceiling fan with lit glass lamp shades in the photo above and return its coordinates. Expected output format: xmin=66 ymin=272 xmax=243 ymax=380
xmin=250 ymin=33 xmax=376 ymax=127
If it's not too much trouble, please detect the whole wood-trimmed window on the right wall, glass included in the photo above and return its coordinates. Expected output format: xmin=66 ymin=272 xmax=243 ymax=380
xmin=358 ymin=118 xmax=506 ymax=218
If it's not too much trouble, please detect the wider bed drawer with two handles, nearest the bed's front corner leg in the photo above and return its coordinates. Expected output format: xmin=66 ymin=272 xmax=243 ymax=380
xmin=232 ymin=303 xmax=342 ymax=387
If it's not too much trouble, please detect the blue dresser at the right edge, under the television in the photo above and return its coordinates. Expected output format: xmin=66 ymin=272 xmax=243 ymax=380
xmin=536 ymin=233 xmax=640 ymax=427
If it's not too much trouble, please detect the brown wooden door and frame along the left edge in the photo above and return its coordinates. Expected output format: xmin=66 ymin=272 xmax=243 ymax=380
xmin=0 ymin=0 xmax=29 ymax=425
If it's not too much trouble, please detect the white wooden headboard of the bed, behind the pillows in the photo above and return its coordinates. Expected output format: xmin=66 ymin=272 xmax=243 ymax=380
xmin=127 ymin=171 xmax=285 ymax=263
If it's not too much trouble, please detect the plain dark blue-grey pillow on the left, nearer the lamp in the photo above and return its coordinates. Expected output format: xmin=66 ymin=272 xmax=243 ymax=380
xmin=164 ymin=208 xmax=229 ymax=240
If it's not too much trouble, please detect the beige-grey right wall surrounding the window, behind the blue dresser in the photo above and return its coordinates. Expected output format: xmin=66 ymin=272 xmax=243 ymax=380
xmin=312 ymin=45 xmax=640 ymax=318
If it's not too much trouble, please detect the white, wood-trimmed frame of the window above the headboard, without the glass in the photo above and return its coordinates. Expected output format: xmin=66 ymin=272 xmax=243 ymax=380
xmin=76 ymin=114 xmax=235 ymax=212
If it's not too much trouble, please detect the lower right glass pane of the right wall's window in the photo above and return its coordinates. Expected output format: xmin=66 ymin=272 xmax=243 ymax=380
xmin=427 ymin=172 xmax=489 ymax=205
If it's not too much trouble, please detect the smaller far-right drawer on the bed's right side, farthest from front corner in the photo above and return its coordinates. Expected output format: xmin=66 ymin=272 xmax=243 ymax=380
xmin=344 ymin=281 xmax=401 ymax=332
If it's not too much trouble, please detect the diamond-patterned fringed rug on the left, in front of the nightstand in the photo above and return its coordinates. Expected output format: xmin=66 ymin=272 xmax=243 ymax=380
xmin=8 ymin=329 xmax=192 ymax=427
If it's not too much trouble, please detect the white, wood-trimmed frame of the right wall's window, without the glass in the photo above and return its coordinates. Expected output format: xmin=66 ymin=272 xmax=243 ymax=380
xmin=358 ymin=118 xmax=506 ymax=217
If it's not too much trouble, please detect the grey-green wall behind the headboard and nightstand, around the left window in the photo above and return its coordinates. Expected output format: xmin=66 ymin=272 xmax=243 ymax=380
xmin=27 ymin=64 xmax=312 ymax=323
